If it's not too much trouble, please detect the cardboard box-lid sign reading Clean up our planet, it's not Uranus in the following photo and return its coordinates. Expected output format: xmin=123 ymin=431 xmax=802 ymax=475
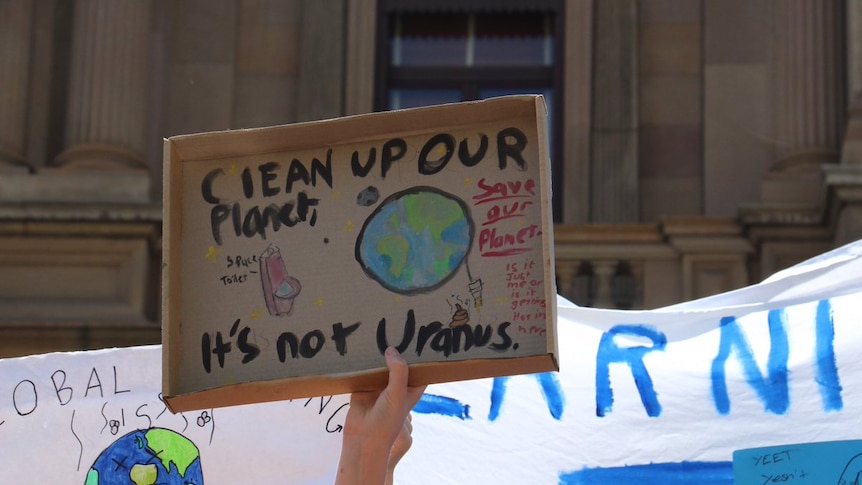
xmin=163 ymin=96 xmax=557 ymax=411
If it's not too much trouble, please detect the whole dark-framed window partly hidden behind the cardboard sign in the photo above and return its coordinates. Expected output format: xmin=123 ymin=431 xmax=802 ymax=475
xmin=375 ymin=0 xmax=564 ymax=221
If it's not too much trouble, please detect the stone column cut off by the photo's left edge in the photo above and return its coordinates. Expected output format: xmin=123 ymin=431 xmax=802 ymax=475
xmin=0 ymin=0 xmax=34 ymax=171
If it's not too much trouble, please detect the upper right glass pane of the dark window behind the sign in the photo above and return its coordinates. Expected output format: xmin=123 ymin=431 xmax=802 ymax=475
xmin=474 ymin=13 xmax=553 ymax=66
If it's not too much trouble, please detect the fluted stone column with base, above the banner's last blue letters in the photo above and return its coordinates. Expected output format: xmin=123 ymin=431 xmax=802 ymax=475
xmin=763 ymin=0 xmax=852 ymax=204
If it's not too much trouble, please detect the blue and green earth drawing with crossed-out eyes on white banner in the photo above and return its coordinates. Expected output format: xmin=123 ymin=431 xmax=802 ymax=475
xmin=84 ymin=428 xmax=204 ymax=485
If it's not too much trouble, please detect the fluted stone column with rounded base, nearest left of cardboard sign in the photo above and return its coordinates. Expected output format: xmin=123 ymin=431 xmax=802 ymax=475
xmin=55 ymin=0 xmax=151 ymax=170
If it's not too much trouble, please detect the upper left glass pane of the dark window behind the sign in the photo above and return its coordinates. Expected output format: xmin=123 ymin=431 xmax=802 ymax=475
xmin=391 ymin=14 xmax=468 ymax=66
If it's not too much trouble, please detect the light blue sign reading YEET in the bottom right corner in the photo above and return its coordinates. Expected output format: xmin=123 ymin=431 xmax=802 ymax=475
xmin=733 ymin=440 xmax=862 ymax=485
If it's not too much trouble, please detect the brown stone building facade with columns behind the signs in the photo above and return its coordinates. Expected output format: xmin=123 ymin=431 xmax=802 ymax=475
xmin=0 ymin=0 xmax=862 ymax=357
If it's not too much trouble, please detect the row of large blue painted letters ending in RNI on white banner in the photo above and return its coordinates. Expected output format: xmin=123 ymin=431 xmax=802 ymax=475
xmin=416 ymin=300 xmax=843 ymax=421
